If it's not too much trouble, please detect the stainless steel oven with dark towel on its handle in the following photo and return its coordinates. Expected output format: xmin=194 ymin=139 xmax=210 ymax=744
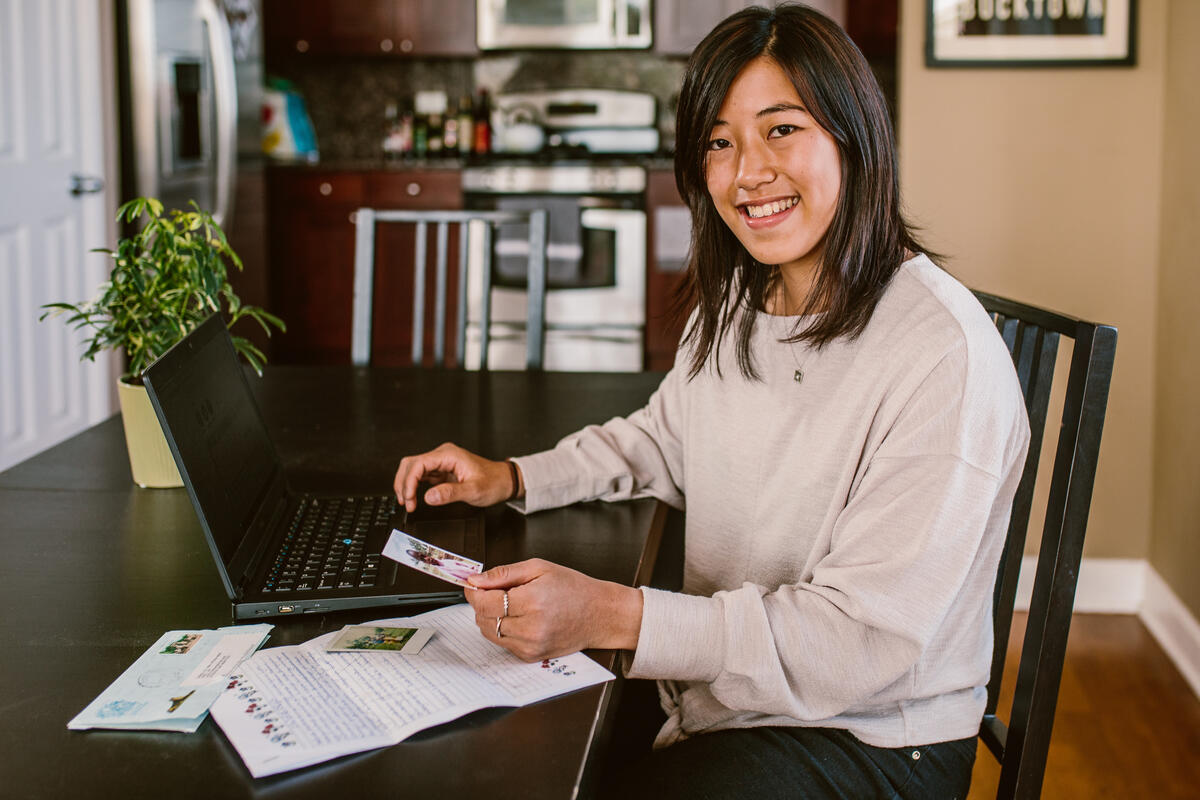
xmin=463 ymin=164 xmax=646 ymax=372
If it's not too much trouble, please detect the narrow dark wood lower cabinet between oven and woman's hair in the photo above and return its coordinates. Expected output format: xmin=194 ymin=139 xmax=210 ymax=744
xmin=646 ymin=169 xmax=691 ymax=369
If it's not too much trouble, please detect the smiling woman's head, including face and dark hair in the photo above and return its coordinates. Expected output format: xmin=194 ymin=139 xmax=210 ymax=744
xmin=676 ymin=2 xmax=916 ymax=375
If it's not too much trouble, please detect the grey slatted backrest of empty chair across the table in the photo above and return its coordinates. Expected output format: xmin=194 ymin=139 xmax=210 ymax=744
xmin=350 ymin=209 xmax=547 ymax=369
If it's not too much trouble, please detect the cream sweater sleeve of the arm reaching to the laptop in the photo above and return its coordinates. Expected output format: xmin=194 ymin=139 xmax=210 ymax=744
xmin=511 ymin=366 xmax=686 ymax=513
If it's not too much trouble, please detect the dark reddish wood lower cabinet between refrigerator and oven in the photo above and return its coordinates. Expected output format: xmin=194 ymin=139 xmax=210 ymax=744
xmin=268 ymin=168 xmax=462 ymax=365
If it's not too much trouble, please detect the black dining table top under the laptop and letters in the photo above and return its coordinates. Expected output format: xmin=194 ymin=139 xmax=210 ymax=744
xmin=0 ymin=366 xmax=676 ymax=800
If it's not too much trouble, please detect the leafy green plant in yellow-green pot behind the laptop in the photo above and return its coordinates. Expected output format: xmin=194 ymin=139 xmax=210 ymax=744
xmin=41 ymin=198 xmax=286 ymax=487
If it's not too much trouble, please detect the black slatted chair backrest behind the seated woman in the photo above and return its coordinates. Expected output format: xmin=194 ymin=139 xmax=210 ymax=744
xmin=976 ymin=291 xmax=1117 ymax=798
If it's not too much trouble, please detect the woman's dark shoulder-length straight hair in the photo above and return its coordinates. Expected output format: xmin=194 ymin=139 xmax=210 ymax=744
xmin=674 ymin=4 xmax=925 ymax=378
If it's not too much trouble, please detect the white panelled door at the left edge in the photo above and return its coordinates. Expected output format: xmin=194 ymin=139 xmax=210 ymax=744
xmin=0 ymin=0 xmax=114 ymax=469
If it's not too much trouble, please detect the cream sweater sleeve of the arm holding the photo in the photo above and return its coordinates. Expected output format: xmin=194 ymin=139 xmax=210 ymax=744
xmin=628 ymin=347 xmax=1027 ymax=721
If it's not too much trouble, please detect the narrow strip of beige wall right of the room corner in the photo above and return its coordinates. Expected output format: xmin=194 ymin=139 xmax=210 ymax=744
xmin=1150 ymin=0 xmax=1200 ymax=616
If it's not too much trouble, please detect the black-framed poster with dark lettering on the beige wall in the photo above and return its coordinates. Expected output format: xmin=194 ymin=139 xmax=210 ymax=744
xmin=925 ymin=0 xmax=1138 ymax=67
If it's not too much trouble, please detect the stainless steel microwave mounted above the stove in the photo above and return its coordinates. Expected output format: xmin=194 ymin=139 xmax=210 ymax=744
xmin=475 ymin=0 xmax=650 ymax=50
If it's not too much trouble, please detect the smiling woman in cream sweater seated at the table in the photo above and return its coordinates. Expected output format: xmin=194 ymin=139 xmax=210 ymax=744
xmin=396 ymin=6 xmax=1028 ymax=798
